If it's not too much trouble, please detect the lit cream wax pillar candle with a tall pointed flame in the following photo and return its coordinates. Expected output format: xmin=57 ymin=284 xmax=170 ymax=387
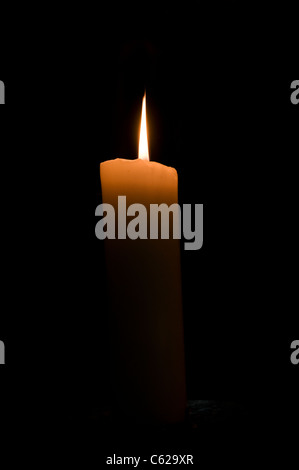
xmin=100 ymin=93 xmax=186 ymax=423
